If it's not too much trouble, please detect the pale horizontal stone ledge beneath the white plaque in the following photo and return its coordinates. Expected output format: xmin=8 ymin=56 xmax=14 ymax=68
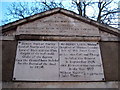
xmin=2 ymin=81 xmax=118 ymax=88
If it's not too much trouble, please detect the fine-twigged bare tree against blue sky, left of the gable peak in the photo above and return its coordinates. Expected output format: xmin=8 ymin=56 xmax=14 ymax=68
xmin=3 ymin=0 xmax=64 ymax=23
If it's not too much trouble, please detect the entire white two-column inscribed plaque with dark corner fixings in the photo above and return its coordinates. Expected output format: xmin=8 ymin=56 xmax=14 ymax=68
xmin=13 ymin=41 xmax=104 ymax=81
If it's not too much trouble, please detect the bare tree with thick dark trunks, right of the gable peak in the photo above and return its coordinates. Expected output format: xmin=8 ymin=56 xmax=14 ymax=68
xmin=72 ymin=0 xmax=120 ymax=24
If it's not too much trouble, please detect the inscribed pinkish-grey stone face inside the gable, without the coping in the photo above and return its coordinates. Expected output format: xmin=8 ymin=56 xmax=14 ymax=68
xmin=17 ymin=13 xmax=99 ymax=36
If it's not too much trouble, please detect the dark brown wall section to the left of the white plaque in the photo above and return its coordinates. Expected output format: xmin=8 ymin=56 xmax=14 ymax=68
xmin=2 ymin=41 xmax=17 ymax=81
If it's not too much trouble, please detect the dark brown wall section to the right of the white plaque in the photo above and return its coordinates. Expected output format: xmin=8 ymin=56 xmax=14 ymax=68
xmin=100 ymin=42 xmax=120 ymax=81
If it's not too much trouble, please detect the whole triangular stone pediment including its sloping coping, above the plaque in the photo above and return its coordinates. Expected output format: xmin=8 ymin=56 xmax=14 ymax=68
xmin=2 ymin=8 xmax=120 ymax=40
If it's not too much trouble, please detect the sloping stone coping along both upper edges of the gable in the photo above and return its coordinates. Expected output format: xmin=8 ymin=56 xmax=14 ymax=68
xmin=0 ymin=8 xmax=120 ymax=36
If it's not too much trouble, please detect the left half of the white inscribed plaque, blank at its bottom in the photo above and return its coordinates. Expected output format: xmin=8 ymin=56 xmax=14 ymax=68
xmin=14 ymin=41 xmax=59 ymax=81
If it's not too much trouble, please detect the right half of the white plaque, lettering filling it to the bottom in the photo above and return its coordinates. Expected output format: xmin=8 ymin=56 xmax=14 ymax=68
xmin=59 ymin=42 xmax=104 ymax=81
